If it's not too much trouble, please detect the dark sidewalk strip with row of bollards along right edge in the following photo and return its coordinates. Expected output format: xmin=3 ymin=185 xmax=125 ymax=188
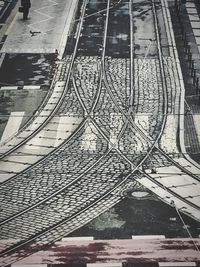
xmin=170 ymin=0 xmax=200 ymax=163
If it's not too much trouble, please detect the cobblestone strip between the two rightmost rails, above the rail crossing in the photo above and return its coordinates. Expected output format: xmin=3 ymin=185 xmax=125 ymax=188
xmin=134 ymin=58 xmax=164 ymax=138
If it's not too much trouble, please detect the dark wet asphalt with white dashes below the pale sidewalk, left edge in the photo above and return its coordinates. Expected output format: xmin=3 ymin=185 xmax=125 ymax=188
xmin=0 ymin=54 xmax=54 ymax=137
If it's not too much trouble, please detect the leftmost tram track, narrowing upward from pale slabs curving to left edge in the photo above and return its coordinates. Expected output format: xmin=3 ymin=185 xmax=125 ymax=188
xmin=0 ymin=0 xmax=94 ymax=178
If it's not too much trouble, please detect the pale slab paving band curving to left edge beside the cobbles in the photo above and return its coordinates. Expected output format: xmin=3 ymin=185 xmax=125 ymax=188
xmin=0 ymin=55 xmax=82 ymax=182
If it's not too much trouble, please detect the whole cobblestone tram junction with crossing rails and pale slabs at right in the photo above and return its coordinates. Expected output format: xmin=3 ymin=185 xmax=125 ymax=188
xmin=0 ymin=0 xmax=200 ymax=265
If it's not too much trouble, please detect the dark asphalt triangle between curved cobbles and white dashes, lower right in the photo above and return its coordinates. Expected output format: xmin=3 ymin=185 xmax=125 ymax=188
xmin=69 ymin=194 xmax=200 ymax=239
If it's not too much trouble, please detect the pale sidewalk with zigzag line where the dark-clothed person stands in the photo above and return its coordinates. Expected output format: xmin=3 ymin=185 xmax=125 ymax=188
xmin=1 ymin=0 xmax=77 ymax=56
